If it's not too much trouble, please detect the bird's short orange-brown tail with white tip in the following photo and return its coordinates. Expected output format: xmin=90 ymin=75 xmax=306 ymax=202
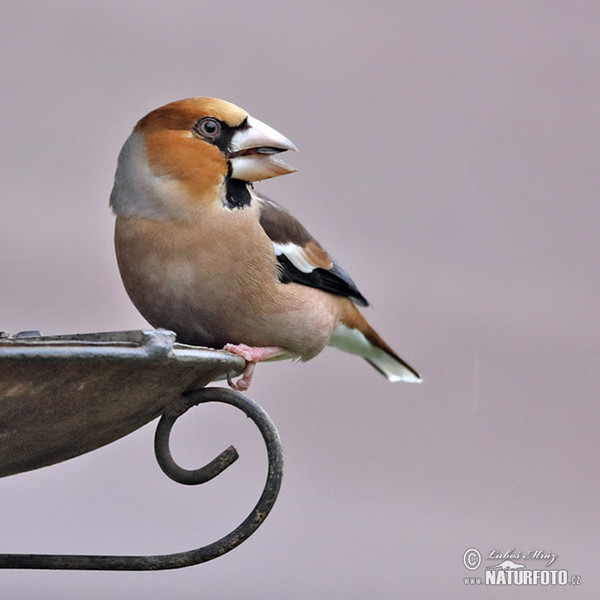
xmin=329 ymin=305 xmax=421 ymax=382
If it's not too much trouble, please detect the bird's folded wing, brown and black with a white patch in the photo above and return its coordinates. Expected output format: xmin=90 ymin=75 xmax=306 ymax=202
xmin=258 ymin=196 xmax=369 ymax=306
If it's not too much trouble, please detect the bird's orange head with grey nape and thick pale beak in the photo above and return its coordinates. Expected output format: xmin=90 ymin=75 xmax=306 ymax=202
xmin=111 ymin=98 xmax=297 ymax=217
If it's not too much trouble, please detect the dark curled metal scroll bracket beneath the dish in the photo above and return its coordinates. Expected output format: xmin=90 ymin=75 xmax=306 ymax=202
xmin=0 ymin=388 xmax=283 ymax=571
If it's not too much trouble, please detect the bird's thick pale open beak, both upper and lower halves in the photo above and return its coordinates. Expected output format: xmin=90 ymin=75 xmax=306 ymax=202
xmin=229 ymin=116 xmax=298 ymax=181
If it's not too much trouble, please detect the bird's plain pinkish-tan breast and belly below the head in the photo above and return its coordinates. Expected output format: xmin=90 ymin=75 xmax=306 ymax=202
xmin=115 ymin=211 xmax=337 ymax=358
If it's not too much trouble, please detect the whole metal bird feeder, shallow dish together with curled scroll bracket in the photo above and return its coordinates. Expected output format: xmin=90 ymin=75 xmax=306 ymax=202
xmin=0 ymin=329 xmax=283 ymax=571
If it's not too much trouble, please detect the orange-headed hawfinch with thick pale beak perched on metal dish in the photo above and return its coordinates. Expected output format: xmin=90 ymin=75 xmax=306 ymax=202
xmin=110 ymin=97 xmax=421 ymax=391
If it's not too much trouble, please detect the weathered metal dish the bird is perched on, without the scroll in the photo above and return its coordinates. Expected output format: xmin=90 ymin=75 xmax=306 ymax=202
xmin=0 ymin=329 xmax=244 ymax=477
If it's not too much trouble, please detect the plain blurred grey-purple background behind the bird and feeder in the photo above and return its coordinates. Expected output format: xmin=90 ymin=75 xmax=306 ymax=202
xmin=0 ymin=0 xmax=600 ymax=600
